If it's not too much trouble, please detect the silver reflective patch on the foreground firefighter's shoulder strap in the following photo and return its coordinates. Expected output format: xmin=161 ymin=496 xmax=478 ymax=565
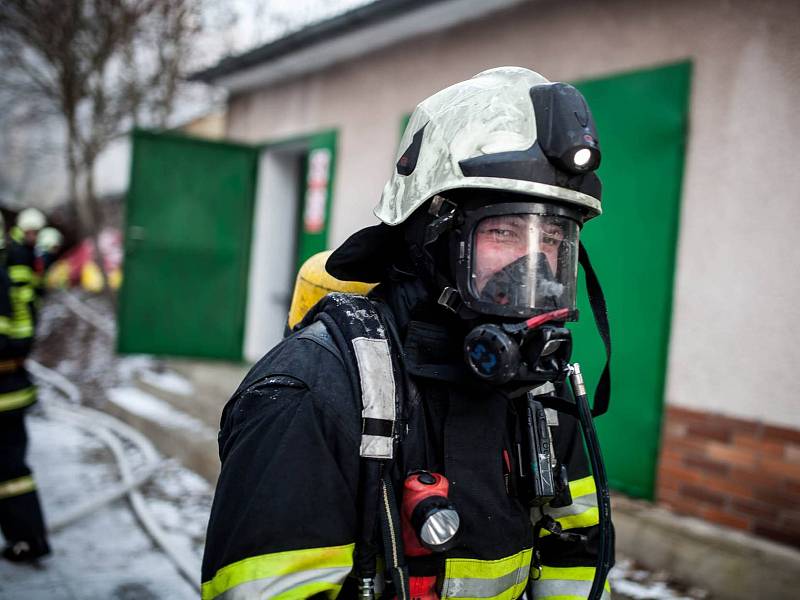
xmin=353 ymin=337 xmax=396 ymax=458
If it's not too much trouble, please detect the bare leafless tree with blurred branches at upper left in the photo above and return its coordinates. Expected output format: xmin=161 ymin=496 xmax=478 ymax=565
xmin=0 ymin=0 xmax=202 ymax=300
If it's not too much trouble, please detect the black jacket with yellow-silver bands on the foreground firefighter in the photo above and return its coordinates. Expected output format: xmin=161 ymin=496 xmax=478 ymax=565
xmin=202 ymin=281 xmax=598 ymax=599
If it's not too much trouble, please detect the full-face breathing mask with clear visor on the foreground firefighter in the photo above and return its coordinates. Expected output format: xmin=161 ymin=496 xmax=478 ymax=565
xmin=418 ymin=192 xmax=582 ymax=385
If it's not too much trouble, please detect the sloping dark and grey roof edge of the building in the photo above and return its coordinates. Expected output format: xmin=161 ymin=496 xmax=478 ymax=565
xmin=189 ymin=0 xmax=526 ymax=92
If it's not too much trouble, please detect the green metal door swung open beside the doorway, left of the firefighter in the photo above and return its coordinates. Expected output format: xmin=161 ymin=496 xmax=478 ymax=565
xmin=118 ymin=131 xmax=258 ymax=360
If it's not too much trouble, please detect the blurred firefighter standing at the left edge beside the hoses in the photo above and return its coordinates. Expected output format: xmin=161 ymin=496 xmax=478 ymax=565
xmin=0 ymin=209 xmax=50 ymax=562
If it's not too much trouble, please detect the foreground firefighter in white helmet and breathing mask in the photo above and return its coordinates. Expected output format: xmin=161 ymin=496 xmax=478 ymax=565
xmin=202 ymin=67 xmax=610 ymax=599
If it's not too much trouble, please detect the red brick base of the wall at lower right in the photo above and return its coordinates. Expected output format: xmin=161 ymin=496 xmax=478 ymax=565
xmin=656 ymin=407 xmax=800 ymax=547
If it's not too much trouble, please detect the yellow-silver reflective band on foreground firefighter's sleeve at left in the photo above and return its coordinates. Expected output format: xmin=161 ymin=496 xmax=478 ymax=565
xmin=202 ymin=544 xmax=355 ymax=600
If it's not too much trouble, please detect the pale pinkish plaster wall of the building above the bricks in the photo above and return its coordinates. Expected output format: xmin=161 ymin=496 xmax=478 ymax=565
xmin=222 ymin=0 xmax=800 ymax=427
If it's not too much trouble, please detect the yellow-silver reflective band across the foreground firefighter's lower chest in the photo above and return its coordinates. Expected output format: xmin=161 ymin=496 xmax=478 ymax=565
xmin=442 ymin=548 xmax=532 ymax=600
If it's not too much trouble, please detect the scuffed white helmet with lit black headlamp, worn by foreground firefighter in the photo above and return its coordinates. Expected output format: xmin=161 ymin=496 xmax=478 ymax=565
xmin=374 ymin=67 xmax=601 ymax=225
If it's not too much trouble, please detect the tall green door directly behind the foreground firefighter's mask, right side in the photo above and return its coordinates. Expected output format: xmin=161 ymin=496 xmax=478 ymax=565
xmin=573 ymin=62 xmax=691 ymax=498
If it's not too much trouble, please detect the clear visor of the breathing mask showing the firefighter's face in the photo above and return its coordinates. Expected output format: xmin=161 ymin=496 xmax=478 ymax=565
xmin=470 ymin=213 xmax=579 ymax=313
